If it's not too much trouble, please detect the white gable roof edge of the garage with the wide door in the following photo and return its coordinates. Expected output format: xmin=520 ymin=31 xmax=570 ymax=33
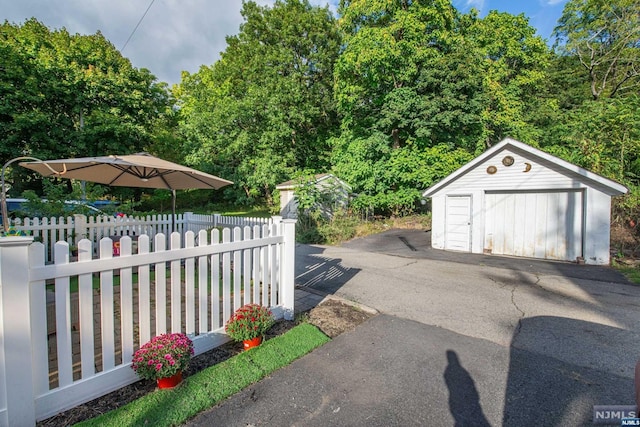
xmin=422 ymin=138 xmax=628 ymax=197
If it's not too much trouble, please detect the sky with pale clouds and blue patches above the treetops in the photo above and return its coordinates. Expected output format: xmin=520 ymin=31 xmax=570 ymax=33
xmin=0 ymin=0 xmax=567 ymax=84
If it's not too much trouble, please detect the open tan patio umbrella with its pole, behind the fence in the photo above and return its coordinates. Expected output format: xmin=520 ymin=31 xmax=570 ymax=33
xmin=20 ymin=153 xmax=233 ymax=229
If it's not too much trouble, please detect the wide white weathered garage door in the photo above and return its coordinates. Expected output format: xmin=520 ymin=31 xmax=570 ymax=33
xmin=484 ymin=191 xmax=583 ymax=261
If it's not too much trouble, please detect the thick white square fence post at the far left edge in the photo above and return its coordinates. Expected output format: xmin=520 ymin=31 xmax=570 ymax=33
xmin=0 ymin=237 xmax=36 ymax=426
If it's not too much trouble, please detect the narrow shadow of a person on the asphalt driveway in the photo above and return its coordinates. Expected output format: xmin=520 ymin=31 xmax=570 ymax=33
xmin=444 ymin=350 xmax=490 ymax=427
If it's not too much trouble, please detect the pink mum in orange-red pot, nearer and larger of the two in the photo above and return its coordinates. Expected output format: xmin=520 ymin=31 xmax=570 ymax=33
xmin=131 ymin=334 xmax=193 ymax=388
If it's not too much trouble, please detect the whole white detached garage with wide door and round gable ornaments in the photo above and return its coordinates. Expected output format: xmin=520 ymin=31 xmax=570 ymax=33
xmin=423 ymin=138 xmax=627 ymax=264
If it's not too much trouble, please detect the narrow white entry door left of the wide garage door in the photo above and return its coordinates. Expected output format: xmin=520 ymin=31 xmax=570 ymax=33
xmin=444 ymin=196 xmax=471 ymax=252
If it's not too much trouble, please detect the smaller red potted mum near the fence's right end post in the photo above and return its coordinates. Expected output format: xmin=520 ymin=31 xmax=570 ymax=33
xmin=224 ymin=304 xmax=275 ymax=350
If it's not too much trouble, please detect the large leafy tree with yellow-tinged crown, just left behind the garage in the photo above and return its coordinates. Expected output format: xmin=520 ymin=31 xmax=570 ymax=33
xmin=333 ymin=0 xmax=482 ymax=214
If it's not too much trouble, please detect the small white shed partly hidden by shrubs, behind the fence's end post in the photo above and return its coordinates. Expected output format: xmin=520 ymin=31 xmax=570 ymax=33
xmin=276 ymin=173 xmax=351 ymax=218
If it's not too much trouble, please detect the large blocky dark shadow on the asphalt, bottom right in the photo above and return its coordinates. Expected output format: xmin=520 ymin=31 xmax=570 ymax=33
xmin=502 ymin=316 xmax=634 ymax=426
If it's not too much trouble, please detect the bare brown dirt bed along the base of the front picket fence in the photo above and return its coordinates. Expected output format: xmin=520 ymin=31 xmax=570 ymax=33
xmin=37 ymin=299 xmax=375 ymax=427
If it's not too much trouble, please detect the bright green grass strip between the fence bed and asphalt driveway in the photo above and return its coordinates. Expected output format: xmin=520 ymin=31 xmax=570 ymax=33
xmin=76 ymin=323 xmax=329 ymax=427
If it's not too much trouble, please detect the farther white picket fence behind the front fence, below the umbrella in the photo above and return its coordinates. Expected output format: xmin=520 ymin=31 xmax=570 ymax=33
xmin=12 ymin=212 xmax=274 ymax=263
